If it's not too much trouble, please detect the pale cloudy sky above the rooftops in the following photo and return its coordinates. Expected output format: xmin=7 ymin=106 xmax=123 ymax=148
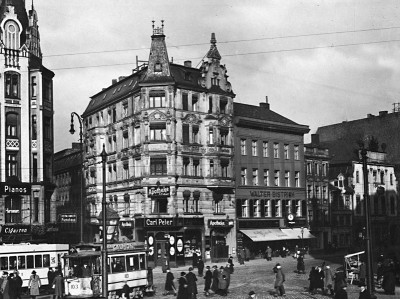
xmin=30 ymin=0 xmax=400 ymax=151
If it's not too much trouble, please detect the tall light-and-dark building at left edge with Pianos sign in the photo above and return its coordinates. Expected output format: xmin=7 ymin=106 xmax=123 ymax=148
xmin=0 ymin=0 xmax=57 ymax=243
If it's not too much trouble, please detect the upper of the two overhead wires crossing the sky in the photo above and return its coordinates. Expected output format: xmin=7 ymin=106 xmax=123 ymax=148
xmin=43 ymin=26 xmax=400 ymax=57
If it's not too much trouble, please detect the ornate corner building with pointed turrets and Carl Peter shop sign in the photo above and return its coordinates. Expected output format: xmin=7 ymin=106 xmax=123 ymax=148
xmin=83 ymin=25 xmax=236 ymax=267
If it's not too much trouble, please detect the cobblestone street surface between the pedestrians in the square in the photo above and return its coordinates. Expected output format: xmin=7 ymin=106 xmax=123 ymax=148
xmin=149 ymin=255 xmax=400 ymax=299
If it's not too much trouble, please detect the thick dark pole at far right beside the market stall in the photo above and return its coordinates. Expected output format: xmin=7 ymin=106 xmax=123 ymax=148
xmin=361 ymin=148 xmax=376 ymax=298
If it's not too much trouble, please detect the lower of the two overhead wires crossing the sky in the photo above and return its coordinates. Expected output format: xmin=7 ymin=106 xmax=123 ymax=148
xmin=48 ymin=39 xmax=400 ymax=71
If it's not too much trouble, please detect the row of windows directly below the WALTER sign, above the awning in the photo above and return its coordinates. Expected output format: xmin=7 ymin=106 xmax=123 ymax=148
xmin=236 ymin=199 xmax=307 ymax=218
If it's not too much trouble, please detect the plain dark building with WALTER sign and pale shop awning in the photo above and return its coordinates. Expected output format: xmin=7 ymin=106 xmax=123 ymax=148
xmin=234 ymin=98 xmax=313 ymax=258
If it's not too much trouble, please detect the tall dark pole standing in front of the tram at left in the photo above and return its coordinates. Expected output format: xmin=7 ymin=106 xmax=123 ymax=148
xmin=100 ymin=144 xmax=108 ymax=298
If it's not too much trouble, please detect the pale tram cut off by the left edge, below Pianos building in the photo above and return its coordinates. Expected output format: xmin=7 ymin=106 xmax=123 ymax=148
xmin=0 ymin=243 xmax=69 ymax=287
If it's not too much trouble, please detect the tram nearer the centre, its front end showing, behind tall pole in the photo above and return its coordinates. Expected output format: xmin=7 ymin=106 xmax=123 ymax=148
xmin=63 ymin=242 xmax=148 ymax=299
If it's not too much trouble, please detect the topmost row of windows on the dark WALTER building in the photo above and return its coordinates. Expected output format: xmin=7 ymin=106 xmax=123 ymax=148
xmin=240 ymin=139 xmax=300 ymax=160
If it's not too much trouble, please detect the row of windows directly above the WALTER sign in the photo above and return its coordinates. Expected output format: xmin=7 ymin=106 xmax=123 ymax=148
xmin=240 ymin=168 xmax=300 ymax=187
